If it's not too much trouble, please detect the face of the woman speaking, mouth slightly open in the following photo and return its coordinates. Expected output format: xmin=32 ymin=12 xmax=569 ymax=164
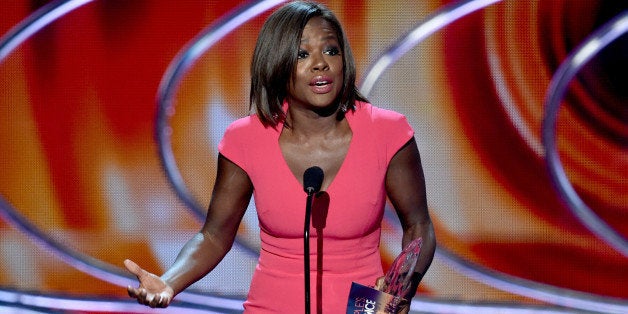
xmin=288 ymin=17 xmax=344 ymax=108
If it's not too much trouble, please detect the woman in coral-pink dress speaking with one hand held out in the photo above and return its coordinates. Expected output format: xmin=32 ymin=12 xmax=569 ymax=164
xmin=125 ymin=1 xmax=436 ymax=313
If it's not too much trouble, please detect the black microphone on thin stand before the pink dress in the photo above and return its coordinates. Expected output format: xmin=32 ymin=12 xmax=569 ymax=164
xmin=303 ymin=166 xmax=324 ymax=314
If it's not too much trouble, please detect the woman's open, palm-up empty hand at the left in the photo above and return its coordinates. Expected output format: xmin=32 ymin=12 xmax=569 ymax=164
xmin=124 ymin=259 xmax=174 ymax=308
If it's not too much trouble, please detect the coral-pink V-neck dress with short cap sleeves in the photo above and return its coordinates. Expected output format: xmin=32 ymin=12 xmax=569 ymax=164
xmin=218 ymin=102 xmax=414 ymax=313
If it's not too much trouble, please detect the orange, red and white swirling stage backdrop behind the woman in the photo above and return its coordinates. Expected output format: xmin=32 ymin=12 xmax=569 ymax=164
xmin=0 ymin=0 xmax=628 ymax=312
